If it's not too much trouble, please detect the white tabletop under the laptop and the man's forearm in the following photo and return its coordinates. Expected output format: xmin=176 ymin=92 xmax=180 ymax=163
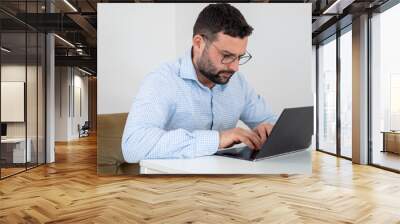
xmin=139 ymin=148 xmax=312 ymax=174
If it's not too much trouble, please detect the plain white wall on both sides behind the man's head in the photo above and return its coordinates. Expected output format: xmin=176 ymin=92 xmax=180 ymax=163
xmin=97 ymin=3 xmax=314 ymax=114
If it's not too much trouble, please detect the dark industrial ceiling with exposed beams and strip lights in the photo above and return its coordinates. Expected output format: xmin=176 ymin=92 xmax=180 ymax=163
xmin=0 ymin=0 xmax=394 ymax=73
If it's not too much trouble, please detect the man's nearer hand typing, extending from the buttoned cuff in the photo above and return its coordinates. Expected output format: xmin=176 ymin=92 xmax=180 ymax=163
xmin=219 ymin=128 xmax=262 ymax=150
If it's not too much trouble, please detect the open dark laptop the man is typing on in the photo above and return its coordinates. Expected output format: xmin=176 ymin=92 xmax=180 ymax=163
xmin=215 ymin=106 xmax=314 ymax=161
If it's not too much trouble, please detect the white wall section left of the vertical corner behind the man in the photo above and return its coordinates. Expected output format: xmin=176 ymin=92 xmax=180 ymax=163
xmin=97 ymin=3 xmax=176 ymax=114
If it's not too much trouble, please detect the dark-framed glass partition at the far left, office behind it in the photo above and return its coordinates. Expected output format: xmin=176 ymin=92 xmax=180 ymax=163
xmin=0 ymin=1 xmax=46 ymax=179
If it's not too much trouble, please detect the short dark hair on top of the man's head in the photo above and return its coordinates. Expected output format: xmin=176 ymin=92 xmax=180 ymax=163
xmin=193 ymin=3 xmax=253 ymax=41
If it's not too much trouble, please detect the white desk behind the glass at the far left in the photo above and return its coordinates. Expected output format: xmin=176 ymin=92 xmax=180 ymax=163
xmin=1 ymin=138 xmax=32 ymax=163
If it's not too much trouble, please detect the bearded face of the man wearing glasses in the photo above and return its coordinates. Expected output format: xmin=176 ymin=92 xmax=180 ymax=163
xmin=196 ymin=32 xmax=248 ymax=84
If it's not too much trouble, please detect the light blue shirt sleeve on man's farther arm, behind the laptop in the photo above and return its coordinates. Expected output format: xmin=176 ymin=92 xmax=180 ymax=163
xmin=240 ymin=77 xmax=278 ymax=129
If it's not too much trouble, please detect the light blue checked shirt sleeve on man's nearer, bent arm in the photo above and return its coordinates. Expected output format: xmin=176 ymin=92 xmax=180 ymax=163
xmin=121 ymin=74 xmax=219 ymax=163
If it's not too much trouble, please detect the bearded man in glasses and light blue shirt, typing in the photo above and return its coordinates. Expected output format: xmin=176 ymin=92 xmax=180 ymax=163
xmin=122 ymin=4 xmax=276 ymax=163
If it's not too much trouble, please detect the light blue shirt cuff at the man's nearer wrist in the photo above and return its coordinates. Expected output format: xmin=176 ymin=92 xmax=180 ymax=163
xmin=193 ymin=130 xmax=219 ymax=157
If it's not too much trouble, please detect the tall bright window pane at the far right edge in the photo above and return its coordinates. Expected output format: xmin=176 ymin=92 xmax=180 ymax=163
xmin=370 ymin=1 xmax=400 ymax=170
